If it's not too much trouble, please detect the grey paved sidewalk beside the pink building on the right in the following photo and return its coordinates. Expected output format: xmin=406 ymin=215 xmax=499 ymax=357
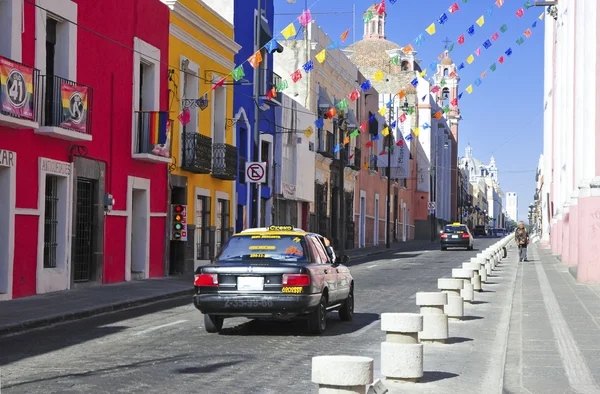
xmin=504 ymin=245 xmax=600 ymax=393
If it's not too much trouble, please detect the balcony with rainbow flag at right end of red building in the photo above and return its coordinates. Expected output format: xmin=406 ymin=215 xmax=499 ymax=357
xmin=131 ymin=111 xmax=173 ymax=164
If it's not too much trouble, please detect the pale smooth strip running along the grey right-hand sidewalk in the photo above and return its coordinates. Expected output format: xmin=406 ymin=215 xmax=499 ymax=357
xmin=534 ymin=256 xmax=598 ymax=393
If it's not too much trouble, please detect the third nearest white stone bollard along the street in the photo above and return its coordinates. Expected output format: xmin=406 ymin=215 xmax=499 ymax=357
xmin=416 ymin=292 xmax=448 ymax=343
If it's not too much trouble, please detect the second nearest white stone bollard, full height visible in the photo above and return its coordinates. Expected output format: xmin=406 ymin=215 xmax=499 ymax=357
xmin=381 ymin=313 xmax=423 ymax=382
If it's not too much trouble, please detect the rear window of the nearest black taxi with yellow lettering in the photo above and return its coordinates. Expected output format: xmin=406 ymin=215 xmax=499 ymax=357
xmin=217 ymin=233 xmax=308 ymax=262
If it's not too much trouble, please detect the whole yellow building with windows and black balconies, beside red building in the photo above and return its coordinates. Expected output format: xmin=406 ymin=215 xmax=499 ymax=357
xmin=162 ymin=0 xmax=241 ymax=274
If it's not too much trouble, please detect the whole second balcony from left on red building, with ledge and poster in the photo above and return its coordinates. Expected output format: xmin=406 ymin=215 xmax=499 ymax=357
xmin=35 ymin=75 xmax=94 ymax=141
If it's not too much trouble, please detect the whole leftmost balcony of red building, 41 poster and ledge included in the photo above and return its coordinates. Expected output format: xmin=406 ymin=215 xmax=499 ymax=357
xmin=0 ymin=56 xmax=40 ymax=129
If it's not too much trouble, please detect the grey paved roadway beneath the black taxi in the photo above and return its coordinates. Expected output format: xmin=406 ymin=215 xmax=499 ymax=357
xmin=0 ymin=239 xmax=497 ymax=394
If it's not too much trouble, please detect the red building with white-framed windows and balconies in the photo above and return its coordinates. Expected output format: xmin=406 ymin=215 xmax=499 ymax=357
xmin=0 ymin=0 xmax=171 ymax=300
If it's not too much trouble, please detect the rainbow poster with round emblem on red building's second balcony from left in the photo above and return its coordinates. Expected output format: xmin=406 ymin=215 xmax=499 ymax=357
xmin=60 ymin=83 xmax=88 ymax=134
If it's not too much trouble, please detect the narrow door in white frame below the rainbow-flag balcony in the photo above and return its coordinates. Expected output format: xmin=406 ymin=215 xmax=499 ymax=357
xmin=131 ymin=189 xmax=149 ymax=280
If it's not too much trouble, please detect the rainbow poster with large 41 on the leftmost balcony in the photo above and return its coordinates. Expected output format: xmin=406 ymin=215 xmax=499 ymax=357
xmin=0 ymin=57 xmax=34 ymax=120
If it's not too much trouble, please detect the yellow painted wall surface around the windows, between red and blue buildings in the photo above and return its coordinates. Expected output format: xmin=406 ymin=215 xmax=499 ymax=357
xmin=169 ymin=0 xmax=236 ymax=227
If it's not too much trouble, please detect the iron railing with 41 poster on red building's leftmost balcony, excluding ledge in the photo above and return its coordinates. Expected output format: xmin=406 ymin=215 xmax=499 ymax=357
xmin=0 ymin=56 xmax=40 ymax=122
